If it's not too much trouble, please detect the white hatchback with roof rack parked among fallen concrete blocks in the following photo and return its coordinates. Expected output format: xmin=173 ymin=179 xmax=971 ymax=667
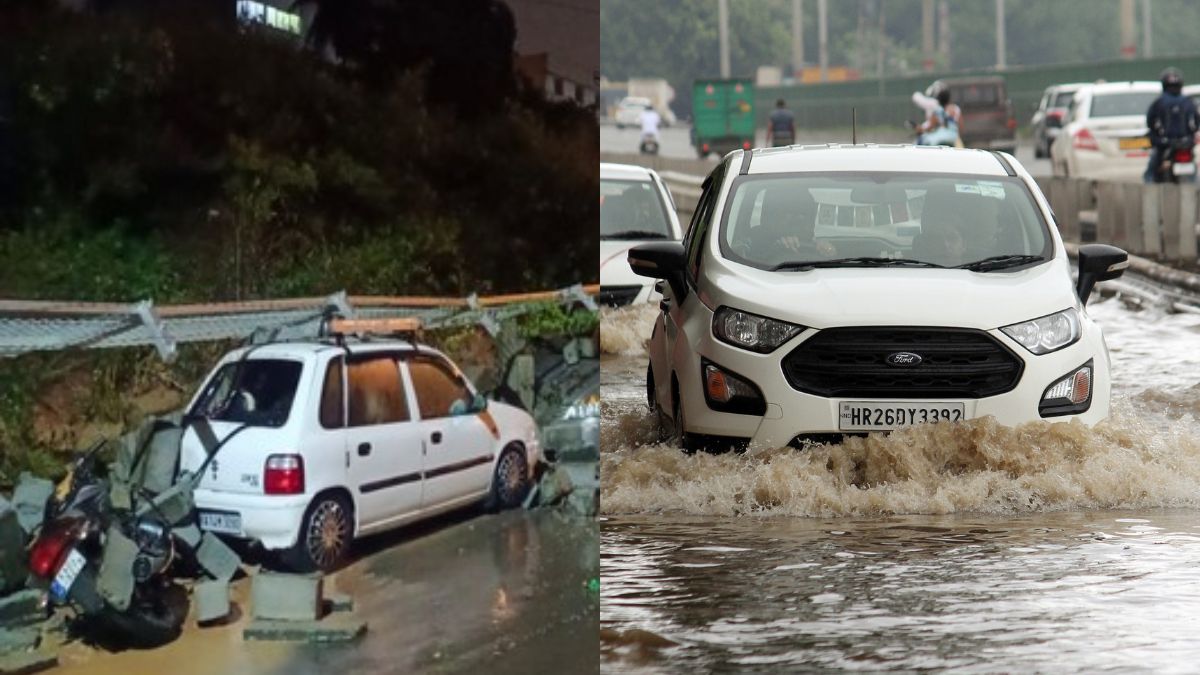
xmin=180 ymin=329 xmax=541 ymax=571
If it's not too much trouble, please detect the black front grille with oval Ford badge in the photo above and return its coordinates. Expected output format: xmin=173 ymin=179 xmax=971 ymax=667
xmin=784 ymin=327 xmax=1025 ymax=399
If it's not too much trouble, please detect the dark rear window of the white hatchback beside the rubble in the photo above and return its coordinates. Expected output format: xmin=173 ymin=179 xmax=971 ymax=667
xmin=192 ymin=359 xmax=302 ymax=426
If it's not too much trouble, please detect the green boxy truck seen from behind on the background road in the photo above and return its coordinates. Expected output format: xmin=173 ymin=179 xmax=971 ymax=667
xmin=691 ymin=79 xmax=755 ymax=159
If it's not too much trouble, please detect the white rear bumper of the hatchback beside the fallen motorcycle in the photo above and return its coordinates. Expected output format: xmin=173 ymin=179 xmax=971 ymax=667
xmin=196 ymin=489 xmax=308 ymax=549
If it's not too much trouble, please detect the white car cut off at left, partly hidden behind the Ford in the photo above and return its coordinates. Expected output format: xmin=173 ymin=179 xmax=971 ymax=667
xmin=599 ymin=163 xmax=683 ymax=306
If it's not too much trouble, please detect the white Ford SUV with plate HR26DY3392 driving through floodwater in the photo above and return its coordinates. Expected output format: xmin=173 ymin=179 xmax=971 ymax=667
xmin=629 ymin=145 xmax=1128 ymax=448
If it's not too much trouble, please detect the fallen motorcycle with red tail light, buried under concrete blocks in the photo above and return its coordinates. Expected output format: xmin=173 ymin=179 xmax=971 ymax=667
xmin=29 ymin=441 xmax=190 ymax=649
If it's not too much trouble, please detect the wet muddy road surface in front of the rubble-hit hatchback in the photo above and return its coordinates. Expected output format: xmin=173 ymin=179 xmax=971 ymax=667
xmin=55 ymin=510 xmax=599 ymax=675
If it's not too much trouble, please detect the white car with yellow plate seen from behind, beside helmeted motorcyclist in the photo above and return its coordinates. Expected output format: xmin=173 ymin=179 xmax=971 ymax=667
xmin=1050 ymin=82 xmax=1163 ymax=183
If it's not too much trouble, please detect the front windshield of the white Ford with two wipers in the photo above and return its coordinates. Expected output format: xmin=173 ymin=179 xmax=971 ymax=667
xmin=720 ymin=173 xmax=1050 ymax=270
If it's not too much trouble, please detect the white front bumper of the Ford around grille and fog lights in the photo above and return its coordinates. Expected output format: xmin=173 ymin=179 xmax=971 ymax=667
xmin=676 ymin=321 xmax=1110 ymax=447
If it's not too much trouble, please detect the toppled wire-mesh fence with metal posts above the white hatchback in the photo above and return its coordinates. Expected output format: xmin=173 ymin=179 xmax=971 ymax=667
xmin=0 ymin=285 xmax=600 ymax=360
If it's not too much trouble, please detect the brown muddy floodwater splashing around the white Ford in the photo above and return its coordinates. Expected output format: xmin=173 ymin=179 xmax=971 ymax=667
xmin=600 ymin=300 xmax=1200 ymax=673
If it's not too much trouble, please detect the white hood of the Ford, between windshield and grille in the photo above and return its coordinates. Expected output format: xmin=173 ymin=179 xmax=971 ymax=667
xmin=702 ymin=255 xmax=1079 ymax=330
